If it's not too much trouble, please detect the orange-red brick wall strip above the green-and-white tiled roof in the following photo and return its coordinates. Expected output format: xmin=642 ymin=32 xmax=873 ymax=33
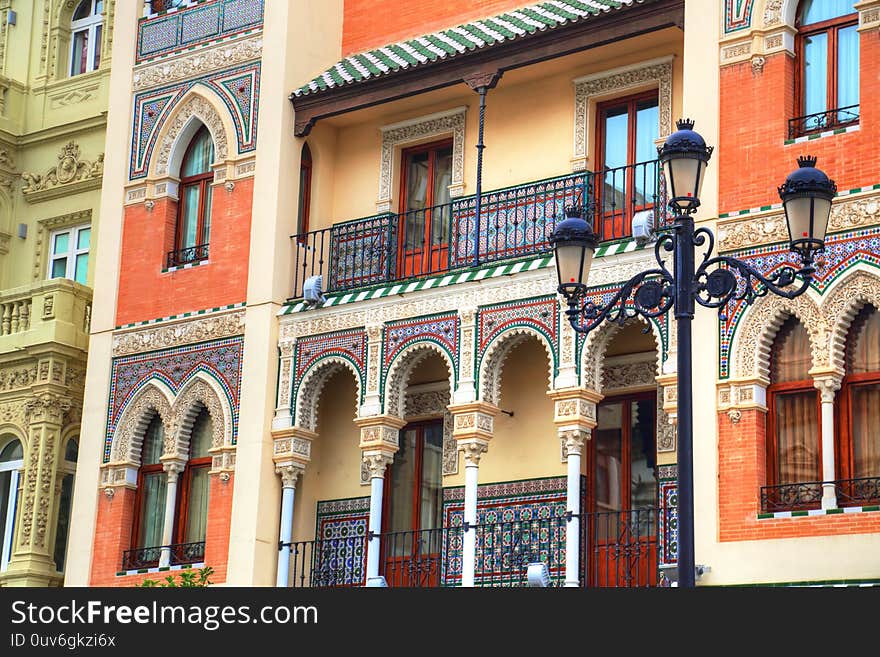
xmin=342 ymin=0 xmax=529 ymax=55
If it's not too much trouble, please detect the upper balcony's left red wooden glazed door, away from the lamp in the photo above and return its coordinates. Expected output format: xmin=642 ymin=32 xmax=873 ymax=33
xmin=398 ymin=141 xmax=452 ymax=278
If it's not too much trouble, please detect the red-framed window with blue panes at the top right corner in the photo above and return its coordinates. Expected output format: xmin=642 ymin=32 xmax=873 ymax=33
xmin=796 ymin=0 xmax=859 ymax=134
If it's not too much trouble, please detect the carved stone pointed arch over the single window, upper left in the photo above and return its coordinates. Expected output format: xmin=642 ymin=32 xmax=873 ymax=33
xmin=150 ymin=84 xmax=235 ymax=177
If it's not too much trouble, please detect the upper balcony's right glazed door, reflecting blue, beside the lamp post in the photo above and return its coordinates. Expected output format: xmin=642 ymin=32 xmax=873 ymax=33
xmin=595 ymin=91 xmax=660 ymax=240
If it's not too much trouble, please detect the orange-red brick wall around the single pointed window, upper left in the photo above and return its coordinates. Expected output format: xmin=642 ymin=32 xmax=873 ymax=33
xmin=116 ymin=178 xmax=253 ymax=325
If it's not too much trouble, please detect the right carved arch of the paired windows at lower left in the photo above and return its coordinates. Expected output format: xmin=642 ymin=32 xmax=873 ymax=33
xmin=172 ymin=372 xmax=232 ymax=458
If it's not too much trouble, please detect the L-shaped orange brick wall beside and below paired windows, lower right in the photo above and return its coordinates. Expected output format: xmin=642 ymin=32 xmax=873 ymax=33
xmin=718 ymin=409 xmax=880 ymax=541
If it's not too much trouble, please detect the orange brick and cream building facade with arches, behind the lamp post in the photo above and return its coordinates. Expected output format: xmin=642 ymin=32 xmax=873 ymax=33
xmin=66 ymin=0 xmax=880 ymax=586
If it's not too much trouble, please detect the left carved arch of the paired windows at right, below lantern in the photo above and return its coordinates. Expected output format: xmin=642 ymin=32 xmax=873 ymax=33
xmin=731 ymin=290 xmax=828 ymax=381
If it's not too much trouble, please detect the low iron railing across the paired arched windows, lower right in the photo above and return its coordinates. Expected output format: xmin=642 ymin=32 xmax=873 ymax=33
xmin=761 ymin=477 xmax=880 ymax=513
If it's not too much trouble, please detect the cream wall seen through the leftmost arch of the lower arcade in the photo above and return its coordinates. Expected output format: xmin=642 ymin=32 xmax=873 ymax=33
xmin=293 ymin=370 xmax=370 ymax=541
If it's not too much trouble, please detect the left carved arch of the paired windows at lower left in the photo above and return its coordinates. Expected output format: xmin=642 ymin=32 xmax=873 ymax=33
xmin=110 ymin=378 xmax=174 ymax=465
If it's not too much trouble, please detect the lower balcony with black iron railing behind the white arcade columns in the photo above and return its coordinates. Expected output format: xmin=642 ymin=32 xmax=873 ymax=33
xmin=290 ymin=508 xmax=674 ymax=588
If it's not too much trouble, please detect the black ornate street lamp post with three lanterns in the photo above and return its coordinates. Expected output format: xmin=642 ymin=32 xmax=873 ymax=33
xmin=550 ymin=119 xmax=837 ymax=587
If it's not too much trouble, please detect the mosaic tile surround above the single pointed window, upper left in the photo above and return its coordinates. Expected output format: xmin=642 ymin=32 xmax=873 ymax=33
xmin=129 ymin=62 xmax=260 ymax=180
